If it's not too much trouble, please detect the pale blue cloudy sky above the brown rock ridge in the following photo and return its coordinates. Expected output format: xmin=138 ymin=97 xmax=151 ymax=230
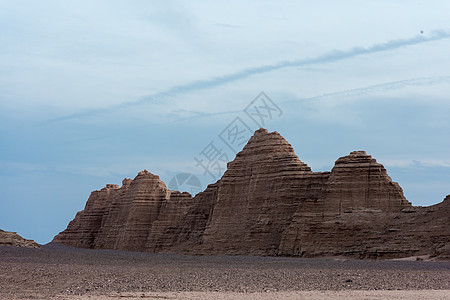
xmin=0 ymin=0 xmax=450 ymax=244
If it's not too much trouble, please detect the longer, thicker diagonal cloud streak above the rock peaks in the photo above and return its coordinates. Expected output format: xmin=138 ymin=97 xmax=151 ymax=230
xmin=44 ymin=30 xmax=450 ymax=124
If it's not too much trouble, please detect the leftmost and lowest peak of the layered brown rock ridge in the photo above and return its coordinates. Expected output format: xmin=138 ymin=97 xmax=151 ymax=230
xmin=53 ymin=170 xmax=193 ymax=251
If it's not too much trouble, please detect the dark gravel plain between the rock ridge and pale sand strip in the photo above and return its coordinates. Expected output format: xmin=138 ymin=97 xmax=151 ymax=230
xmin=0 ymin=245 xmax=450 ymax=299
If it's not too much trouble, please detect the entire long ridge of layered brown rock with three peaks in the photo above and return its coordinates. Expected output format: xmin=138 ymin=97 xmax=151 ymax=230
xmin=53 ymin=129 xmax=450 ymax=258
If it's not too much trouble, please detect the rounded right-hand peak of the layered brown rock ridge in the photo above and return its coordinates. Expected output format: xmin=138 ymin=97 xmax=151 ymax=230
xmin=278 ymin=151 xmax=411 ymax=256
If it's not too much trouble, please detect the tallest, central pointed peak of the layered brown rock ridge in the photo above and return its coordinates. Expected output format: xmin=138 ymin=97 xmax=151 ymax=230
xmin=202 ymin=129 xmax=328 ymax=255
